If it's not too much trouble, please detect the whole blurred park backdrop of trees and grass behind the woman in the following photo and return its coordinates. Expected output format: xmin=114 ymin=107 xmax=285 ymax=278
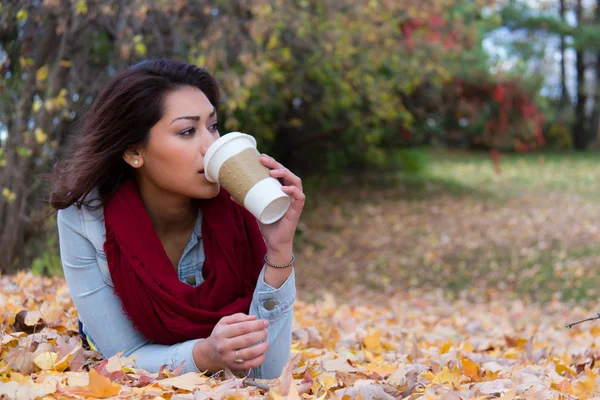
xmin=0 ymin=0 xmax=600 ymax=301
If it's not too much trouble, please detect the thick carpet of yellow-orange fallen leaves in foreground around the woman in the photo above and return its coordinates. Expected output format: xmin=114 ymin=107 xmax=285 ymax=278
xmin=0 ymin=273 xmax=600 ymax=399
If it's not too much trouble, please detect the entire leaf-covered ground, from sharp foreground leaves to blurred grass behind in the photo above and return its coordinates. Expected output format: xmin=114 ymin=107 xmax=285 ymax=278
xmin=0 ymin=154 xmax=600 ymax=399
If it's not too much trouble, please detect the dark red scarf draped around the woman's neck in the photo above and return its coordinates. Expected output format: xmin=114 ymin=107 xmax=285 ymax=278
xmin=104 ymin=181 xmax=266 ymax=344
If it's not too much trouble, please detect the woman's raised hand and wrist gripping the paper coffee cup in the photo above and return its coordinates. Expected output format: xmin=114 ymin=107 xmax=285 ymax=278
xmin=259 ymin=154 xmax=306 ymax=263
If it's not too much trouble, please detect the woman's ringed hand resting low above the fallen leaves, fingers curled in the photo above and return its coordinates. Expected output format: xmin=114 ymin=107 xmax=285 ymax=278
xmin=194 ymin=313 xmax=269 ymax=371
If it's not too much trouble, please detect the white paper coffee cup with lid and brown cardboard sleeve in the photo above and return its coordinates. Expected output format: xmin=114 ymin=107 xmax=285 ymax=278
xmin=204 ymin=132 xmax=291 ymax=224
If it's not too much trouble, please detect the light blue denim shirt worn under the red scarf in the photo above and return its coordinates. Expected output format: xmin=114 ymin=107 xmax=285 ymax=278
xmin=57 ymin=197 xmax=296 ymax=379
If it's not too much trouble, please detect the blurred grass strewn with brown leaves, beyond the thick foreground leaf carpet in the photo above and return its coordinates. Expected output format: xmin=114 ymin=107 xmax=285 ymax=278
xmin=298 ymin=153 xmax=600 ymax=302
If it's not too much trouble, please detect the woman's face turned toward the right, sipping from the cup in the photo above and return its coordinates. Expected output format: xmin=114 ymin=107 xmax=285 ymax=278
xmin=139 ymin=86 xmax=219 ymax=199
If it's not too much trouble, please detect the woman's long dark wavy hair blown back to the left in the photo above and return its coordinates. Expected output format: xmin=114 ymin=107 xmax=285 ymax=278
xmin=50 ymin=59 xmax=219 ymax=210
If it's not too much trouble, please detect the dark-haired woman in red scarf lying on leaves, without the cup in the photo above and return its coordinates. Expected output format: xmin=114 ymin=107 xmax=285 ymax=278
xmin=51 ymin=60 xmax=305 ymax=379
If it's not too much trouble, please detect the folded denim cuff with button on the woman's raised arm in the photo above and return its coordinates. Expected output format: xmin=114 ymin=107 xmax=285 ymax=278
xmin=253 ymin=267 xmax=296 ymax=321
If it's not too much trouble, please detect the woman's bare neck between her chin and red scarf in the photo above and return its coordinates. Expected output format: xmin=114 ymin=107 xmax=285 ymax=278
xmin=138 ymin=177 xmax=197 ymax=237
